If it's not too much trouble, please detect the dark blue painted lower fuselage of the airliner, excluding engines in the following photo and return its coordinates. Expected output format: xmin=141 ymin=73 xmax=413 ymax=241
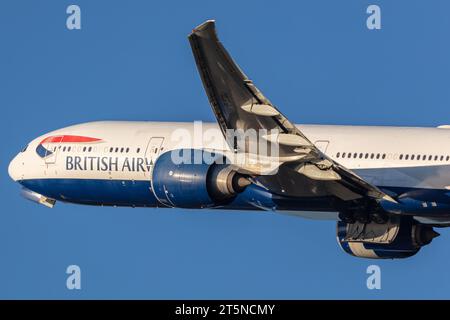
xmin=19 ymin=179 xmax=450 ymax=216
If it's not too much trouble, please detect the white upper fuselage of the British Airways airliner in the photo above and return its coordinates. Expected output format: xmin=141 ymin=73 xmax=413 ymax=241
xmin=9 ymin=121 xmax=450 ymax=189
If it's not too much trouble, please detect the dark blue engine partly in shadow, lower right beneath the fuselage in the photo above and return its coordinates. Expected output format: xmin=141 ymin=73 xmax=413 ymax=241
xmin=337 ymin=217 xmax=439 ymax=259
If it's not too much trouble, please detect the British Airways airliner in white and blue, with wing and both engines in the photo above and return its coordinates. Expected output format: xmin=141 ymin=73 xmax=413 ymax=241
xmin=8 ymin=20 xmax=450 ymax=259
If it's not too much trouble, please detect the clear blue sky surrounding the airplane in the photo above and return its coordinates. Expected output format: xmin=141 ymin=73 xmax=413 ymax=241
xmin=0 ymin=0 xmax=450 ymax=299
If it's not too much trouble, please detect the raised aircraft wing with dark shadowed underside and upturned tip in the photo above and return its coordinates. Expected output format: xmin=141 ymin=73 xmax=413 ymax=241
xmin=189 ymin=20 xmax=395 ymax=201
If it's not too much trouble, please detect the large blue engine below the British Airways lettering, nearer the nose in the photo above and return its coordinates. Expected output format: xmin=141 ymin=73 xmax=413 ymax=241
xmin=152 ymin=149 xmax=250 ymax=208
